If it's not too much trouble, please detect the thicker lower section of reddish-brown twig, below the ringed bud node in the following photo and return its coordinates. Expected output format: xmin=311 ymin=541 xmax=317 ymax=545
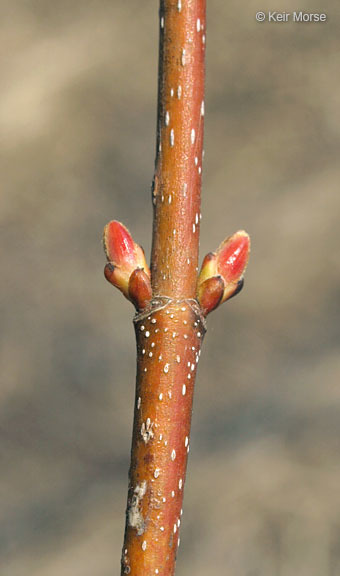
xmin=123 ymin=298 xmax=205 ymax=576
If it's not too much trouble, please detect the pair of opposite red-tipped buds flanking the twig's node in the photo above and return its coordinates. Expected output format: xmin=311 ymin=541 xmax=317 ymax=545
xmin=103 ymin=220 xmax=250 ymax=316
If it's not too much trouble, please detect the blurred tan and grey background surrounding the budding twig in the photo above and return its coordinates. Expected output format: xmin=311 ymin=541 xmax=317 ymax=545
xmin=0 ymin=0 xmax=340 ymax=576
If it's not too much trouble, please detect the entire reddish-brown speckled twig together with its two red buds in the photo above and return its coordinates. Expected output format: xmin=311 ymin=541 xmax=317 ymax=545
xmin=104 ymin=0 xmax=249 ymax=576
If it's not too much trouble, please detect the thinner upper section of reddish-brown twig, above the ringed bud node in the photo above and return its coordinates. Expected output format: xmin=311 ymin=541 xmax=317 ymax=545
xmin=151 ymin=0 xmax=205 ymax=298
